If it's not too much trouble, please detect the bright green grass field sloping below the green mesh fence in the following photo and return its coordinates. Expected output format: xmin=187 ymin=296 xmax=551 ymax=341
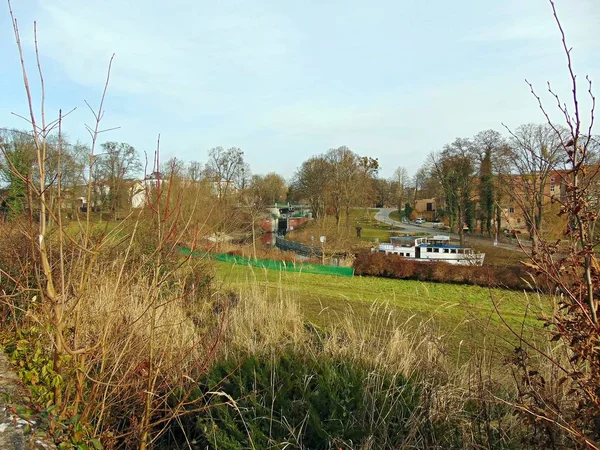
xmin=216 ymin=263 xmax=550 ymax=356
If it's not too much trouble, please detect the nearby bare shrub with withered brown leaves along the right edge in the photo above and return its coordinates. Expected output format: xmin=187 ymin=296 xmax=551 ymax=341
xmin=506 ymin=0 xmax=600 ymax=449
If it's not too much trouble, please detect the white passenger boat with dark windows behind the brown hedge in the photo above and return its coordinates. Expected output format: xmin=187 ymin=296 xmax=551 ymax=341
xmin=371 ymin=236 xmax=485 ymax=266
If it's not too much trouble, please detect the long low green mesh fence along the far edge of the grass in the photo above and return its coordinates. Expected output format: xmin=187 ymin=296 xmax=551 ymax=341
xmin=181 ymin=247 xmax=354 ymax=277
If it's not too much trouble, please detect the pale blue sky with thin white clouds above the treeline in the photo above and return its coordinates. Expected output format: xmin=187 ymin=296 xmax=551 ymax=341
xmin=0 ymin=0 xmax=600 ymax=179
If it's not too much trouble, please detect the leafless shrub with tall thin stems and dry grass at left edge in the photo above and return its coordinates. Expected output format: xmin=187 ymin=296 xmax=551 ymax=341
xmin=0 ymin=1 xmax=224 ymax=448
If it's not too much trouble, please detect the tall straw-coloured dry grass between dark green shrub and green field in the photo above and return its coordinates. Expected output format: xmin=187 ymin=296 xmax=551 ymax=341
xmin=206 ymin=281 xmax=522 ymax=449
